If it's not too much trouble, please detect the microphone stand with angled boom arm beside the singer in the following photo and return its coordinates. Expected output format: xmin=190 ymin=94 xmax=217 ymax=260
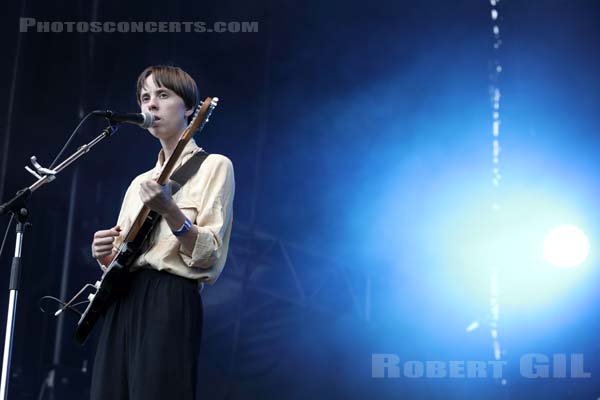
xmin=0 ymin=124 xmax=119 ymax=400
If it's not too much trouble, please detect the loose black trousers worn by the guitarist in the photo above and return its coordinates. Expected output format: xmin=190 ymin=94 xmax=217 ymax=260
xmin=91 ymin=269 xmax=202 ymax=400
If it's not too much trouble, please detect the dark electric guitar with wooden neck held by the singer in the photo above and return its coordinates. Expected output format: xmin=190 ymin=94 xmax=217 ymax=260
xmin=74 ymin=97 xmax=219 ymax=344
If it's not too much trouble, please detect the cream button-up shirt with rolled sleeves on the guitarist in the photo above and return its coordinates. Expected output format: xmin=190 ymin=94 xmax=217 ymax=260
xmin=103 ymin=139 xmax=235 ymax=283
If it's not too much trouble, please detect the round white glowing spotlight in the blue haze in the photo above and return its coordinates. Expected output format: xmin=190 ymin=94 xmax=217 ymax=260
xmin=544 ymin=225 xmax=590 ymax=268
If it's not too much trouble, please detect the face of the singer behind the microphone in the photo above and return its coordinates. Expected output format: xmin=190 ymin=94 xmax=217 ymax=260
xmin=140 ymin=75 xmax=192 ymax=140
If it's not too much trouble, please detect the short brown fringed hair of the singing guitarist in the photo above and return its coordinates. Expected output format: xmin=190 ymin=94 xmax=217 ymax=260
xmin=135 ymin=65 xmax=199 ymax=110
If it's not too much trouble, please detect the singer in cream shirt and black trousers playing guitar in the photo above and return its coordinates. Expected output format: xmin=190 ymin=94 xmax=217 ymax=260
xmin=91 ymin=65 xmax=235 ymax=400
